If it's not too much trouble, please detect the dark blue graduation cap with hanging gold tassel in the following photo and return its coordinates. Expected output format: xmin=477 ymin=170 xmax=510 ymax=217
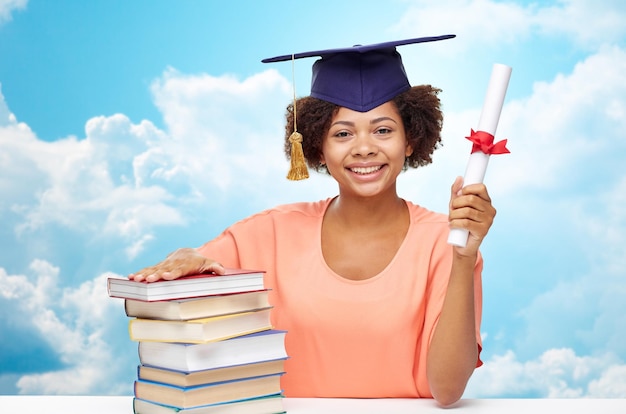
xmin=262 ymin=35 xmax=455 ymax=179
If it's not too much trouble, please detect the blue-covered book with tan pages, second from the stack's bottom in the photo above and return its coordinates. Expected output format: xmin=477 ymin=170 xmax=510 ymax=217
xmin=135 ymin=374 xmax=282 ymax=408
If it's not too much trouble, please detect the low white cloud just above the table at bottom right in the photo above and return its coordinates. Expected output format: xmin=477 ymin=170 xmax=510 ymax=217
xmin=465 ymin=348 xmax=626 ymax=398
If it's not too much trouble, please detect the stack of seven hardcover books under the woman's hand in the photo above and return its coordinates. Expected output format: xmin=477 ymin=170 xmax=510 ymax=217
xmin=107 ymin=269 xmax=287 ymax=414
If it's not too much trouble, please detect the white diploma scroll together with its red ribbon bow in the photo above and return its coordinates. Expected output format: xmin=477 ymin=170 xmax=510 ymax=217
xmin=448 ymin=63 xmax=512 ymax=247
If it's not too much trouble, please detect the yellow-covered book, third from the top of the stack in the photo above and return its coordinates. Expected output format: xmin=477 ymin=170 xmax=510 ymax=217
xmin=128 ymin=309 xmax=272 ymax=343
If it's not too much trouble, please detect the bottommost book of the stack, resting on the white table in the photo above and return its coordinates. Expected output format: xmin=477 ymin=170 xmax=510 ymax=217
xmin=133 ymin=394 xmax=285 ymax=414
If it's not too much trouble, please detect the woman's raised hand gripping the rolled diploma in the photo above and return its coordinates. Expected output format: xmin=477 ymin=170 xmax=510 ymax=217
xmin=448 ymin=177 xmax=496 ymax=256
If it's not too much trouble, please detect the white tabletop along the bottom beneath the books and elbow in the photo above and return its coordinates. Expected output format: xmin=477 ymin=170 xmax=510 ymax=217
xmin=0 ymin=395 xmax=626 ymax=414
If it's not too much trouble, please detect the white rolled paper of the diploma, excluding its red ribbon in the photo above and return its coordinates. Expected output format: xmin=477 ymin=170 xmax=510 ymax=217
xmin=448 ymin=63 xmax=512 ymax=247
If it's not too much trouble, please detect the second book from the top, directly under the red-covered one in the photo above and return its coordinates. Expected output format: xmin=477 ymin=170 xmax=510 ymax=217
xmin=124 ymin=290 xmax=270 ymax=321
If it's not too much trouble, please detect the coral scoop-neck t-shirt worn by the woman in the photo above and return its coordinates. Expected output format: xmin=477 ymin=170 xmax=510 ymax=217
xmin=199 ymin=199 xmax=482 ymax=398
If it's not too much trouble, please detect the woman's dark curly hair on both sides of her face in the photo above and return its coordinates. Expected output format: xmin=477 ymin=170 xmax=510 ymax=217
xmin=285 ymin=85 xmax=443 ymax=172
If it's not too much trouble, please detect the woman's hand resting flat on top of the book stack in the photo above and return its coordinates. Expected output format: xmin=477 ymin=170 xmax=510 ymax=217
xmin=128 ymin=247 xmax=225 ymax=282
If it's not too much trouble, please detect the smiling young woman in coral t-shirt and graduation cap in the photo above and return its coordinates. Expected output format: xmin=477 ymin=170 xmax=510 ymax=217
xmin=129 ymin=38 xmax=495 ymax=405
